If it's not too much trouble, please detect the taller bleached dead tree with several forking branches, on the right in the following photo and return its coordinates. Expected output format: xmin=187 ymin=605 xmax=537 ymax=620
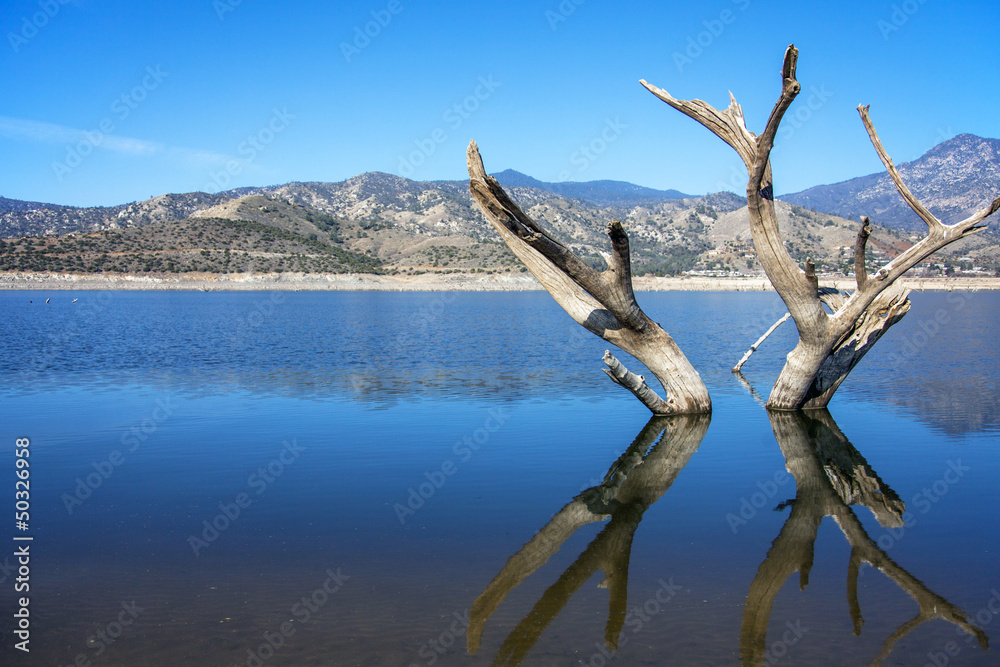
xmin=641 ymin=46 xmax=1000 ymax=410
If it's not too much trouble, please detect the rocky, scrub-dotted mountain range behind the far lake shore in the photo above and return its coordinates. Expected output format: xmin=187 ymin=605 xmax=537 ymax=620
xmin=0 ymin=134 xmax=1000 ymax=275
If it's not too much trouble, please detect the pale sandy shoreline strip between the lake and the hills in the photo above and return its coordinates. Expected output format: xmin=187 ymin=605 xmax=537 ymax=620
xmin=0 ymin=272 xmax=1000 ymax=292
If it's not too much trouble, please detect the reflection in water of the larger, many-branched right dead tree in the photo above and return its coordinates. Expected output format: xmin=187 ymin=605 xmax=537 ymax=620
xmin=740 ymin=410 xmax=988 ymax=665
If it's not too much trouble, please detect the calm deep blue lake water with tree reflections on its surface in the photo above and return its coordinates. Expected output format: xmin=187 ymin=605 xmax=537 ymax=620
xmin=0 ymin=292 xmax=1000 ymax=666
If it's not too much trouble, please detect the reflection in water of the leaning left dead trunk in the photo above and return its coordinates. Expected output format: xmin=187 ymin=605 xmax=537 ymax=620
xmin=467 ymin=415 xmax=709 ymax=665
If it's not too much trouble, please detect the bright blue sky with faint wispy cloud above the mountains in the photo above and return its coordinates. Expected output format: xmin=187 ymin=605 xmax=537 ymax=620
xmin=0 ymin=0 xmax=1000 ymax=205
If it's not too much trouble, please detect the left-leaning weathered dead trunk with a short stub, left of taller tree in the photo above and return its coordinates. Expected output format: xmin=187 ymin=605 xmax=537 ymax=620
xmin=467 ymin=141 xmax=712 ymax=415
